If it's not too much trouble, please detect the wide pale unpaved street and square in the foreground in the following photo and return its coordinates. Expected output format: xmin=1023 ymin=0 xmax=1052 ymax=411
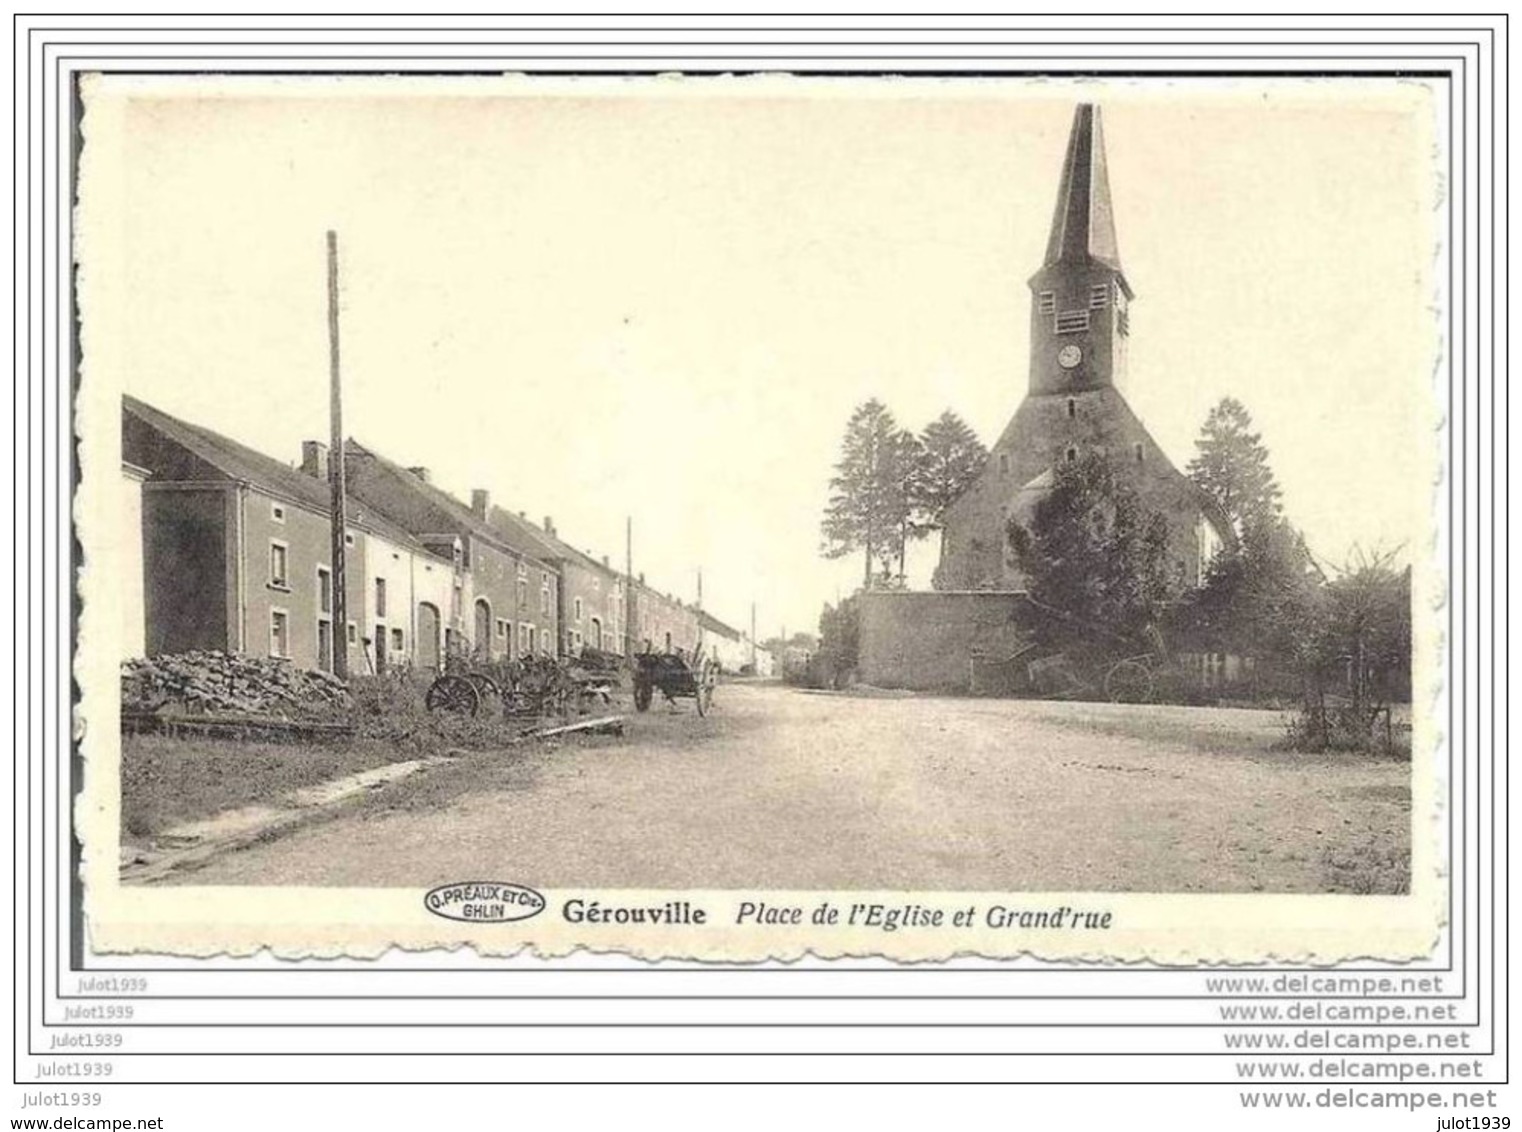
xmin=166 ymin=685 xmax=1411 ymax=892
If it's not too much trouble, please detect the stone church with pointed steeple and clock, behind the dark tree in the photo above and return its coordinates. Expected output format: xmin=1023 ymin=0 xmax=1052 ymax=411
xmin=935 ymin=103 xmax=1231 ymax=592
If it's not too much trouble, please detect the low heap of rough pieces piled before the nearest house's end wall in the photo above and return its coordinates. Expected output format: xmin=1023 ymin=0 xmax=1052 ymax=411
xmin=122 ymin=651 xmax=349 ymax=717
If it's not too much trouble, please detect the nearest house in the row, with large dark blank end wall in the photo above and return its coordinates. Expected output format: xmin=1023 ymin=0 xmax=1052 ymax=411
xmin=122 ymin=397 xmax=455 ymax=673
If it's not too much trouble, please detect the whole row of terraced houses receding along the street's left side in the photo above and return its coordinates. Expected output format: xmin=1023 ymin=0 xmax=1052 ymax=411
xmin=122 ymin=397 xmax=770 ymax=674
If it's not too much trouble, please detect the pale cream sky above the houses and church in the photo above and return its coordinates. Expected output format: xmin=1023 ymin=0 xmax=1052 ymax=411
xmin=76 ymin=78 xmax=1443 ymax=638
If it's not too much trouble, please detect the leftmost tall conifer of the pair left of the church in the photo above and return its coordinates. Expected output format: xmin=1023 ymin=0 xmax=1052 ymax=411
xmin=820 ymin=397 xmax=918 ymax=587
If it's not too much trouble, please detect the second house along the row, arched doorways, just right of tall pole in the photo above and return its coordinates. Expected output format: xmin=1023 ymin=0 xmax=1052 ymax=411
xmin=345 ymin=440 xmax=560 ymax=666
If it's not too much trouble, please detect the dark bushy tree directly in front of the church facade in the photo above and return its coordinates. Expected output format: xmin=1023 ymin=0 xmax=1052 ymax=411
xmin=1008 ymin=453 xmax=1183 ymax=634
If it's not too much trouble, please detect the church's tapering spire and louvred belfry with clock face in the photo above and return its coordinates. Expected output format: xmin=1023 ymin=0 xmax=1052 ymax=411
xmin=1030 ymin=102 xmax=1131 ymax=396
